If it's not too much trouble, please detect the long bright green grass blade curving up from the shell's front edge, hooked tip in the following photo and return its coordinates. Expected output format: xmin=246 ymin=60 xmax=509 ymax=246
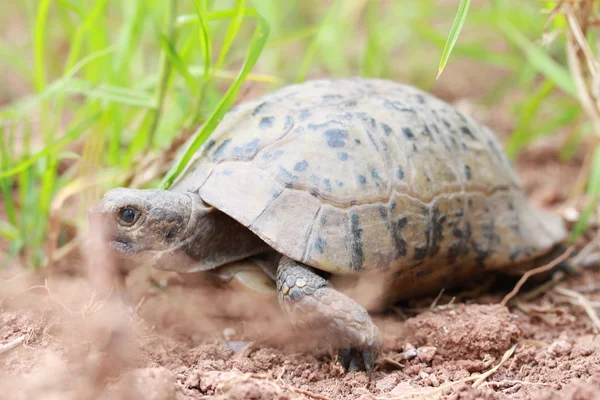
xmin=159 ymin=8 xmax=269 ymax=189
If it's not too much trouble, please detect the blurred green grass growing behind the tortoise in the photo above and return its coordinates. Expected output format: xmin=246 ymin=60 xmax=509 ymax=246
xmin=0 ymin=0 xmax=600 ymax=267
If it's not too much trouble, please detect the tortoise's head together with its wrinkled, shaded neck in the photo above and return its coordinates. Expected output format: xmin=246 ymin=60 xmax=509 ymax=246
xmin=89 ymin=188 xmax=270 ymax=272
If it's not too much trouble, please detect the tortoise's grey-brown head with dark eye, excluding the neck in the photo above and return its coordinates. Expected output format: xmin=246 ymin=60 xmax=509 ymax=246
xmin=89 ymin=188 xmax=203 ymax=262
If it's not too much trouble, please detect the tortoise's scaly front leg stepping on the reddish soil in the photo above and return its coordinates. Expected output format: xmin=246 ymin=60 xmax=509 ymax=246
xmin=277 ymin=256 xmax=382 ymax=371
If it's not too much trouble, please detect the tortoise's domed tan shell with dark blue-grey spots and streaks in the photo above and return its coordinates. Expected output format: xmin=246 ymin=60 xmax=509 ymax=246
xmin=172 ymin=78 xmax=564 ymax=278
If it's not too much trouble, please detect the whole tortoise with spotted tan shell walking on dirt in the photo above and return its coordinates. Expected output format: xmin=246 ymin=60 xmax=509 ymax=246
xmin=92 ymin=78 xmax=566 ymax=371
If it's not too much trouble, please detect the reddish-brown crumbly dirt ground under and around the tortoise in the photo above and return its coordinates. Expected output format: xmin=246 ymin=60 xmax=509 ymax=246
xmin=0 ymin=61 xmax=600 ymax=400
